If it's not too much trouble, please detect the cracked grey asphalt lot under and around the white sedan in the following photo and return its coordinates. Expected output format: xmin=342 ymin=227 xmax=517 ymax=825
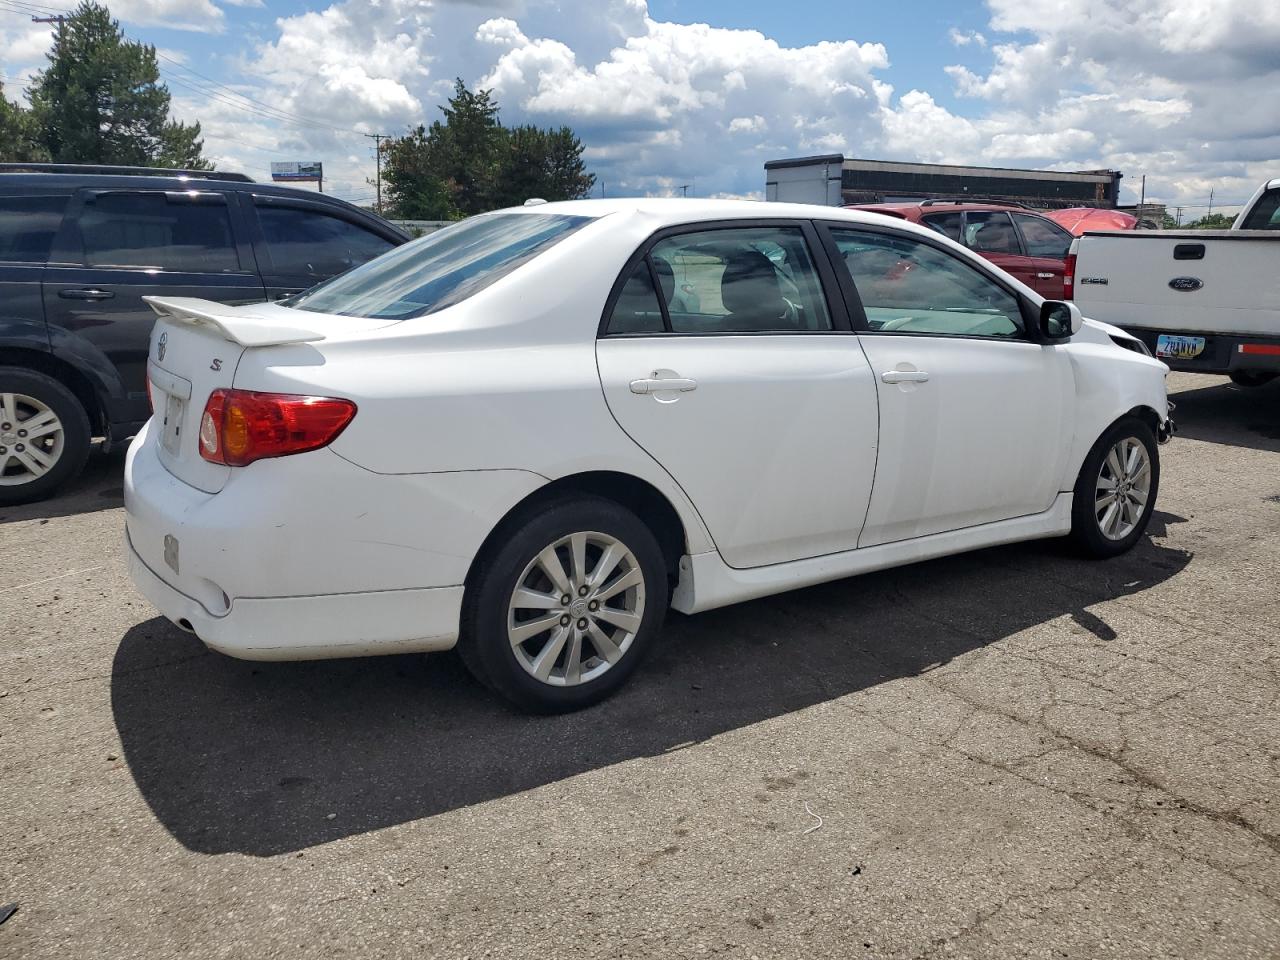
xmin=0 ymin=375 xmax=1280 ymax=960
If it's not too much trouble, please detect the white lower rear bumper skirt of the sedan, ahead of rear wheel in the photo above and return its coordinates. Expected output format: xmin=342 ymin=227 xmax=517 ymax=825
xmin=125 ymin=532 xmax=462 ymax=660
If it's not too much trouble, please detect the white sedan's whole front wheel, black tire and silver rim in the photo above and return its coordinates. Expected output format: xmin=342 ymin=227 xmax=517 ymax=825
xmin=1071 ymin=416 xmax=1160 ymax=559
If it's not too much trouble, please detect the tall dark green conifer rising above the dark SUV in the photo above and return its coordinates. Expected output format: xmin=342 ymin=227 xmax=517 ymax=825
xmin=31 ymin=0 xmax=209 ymax=169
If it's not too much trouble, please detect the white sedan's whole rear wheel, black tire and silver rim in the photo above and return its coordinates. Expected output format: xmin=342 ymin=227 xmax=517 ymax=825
xmin=458 ymin=495 xmax=669 ymax=713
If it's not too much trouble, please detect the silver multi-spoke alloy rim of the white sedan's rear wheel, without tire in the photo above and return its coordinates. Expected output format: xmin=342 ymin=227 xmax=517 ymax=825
xmin=507 ymin=531 xmax=645 ymax=686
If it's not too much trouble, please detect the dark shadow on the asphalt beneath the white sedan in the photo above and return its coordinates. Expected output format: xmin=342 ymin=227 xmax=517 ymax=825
xmin=111 ymin=513 xmax=1192 ymax=856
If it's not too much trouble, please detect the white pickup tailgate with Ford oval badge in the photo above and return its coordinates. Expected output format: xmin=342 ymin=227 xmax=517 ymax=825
xmin=1075 ymin=230 xmax=1280 ymax=337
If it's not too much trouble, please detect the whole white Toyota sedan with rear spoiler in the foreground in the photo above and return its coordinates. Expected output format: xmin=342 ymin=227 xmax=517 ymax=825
xmin=125 ymin=200 xmax=1172 ymax=710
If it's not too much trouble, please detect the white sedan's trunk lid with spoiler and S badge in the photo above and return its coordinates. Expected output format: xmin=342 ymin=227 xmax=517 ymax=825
xmin=143 ymin=297 xmax=393 ymax=493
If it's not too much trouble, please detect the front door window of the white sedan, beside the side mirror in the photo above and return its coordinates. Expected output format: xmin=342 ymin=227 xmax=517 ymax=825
xmin=831 ymin=229 xmax=1024 ymax=338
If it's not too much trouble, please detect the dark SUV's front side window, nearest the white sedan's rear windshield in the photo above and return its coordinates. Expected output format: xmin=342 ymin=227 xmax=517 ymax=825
xmin=257 ymin=204 xmax=396 ymax=276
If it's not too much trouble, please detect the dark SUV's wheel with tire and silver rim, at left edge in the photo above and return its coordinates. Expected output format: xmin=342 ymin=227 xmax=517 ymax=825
xmin=0 ymin=366 xmax=93 ymax=506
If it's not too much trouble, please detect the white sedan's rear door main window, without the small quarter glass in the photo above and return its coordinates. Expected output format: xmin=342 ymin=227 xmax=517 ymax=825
xmin=649 ymin=227 xmax=831 ymax=333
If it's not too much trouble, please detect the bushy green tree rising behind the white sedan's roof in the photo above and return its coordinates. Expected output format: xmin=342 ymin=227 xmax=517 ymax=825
xmin=383 ymin=79 xmax=595 ymax=220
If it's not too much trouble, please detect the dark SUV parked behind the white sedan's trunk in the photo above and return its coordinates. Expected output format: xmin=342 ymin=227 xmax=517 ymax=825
xmin=0 ymin=164 xmax=408 ymax=504
